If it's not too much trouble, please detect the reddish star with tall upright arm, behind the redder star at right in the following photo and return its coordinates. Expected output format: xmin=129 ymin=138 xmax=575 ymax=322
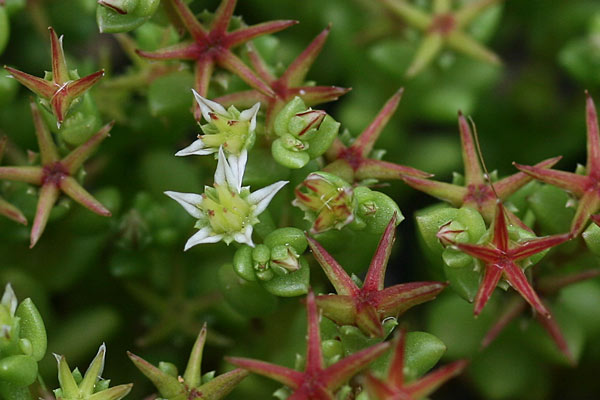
xmin=403 ymin=111 xmax=561 ymax=231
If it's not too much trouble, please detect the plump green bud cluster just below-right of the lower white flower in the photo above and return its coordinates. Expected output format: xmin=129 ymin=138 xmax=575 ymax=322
xmin=233 ymin=227 xmax=310 ymax=297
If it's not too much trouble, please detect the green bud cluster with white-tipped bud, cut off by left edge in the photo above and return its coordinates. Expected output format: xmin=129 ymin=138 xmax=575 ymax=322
xmin=0 ymin=284 xmax=47 ymax=399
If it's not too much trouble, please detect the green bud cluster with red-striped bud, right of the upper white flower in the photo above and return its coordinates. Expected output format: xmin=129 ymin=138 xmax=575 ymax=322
xmin=271 ymin=97 xmax=340 ymax=168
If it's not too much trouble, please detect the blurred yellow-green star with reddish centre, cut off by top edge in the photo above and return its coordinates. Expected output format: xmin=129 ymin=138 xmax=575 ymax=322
xmin=381 ymin=0 xmax=502 ymax=77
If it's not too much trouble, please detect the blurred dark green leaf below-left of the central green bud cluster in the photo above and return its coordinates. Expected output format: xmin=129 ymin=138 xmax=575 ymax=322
xmin=218 ymin=264 xmax=277 ymax=317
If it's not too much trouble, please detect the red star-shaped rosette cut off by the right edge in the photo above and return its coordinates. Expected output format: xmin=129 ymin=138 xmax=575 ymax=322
xmin=514 ymin=91 xmax=600 ymax=236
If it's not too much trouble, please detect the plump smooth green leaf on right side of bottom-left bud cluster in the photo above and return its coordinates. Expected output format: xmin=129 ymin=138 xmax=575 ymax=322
xmin=15 ymin=298 xmax=48 ymax=361
